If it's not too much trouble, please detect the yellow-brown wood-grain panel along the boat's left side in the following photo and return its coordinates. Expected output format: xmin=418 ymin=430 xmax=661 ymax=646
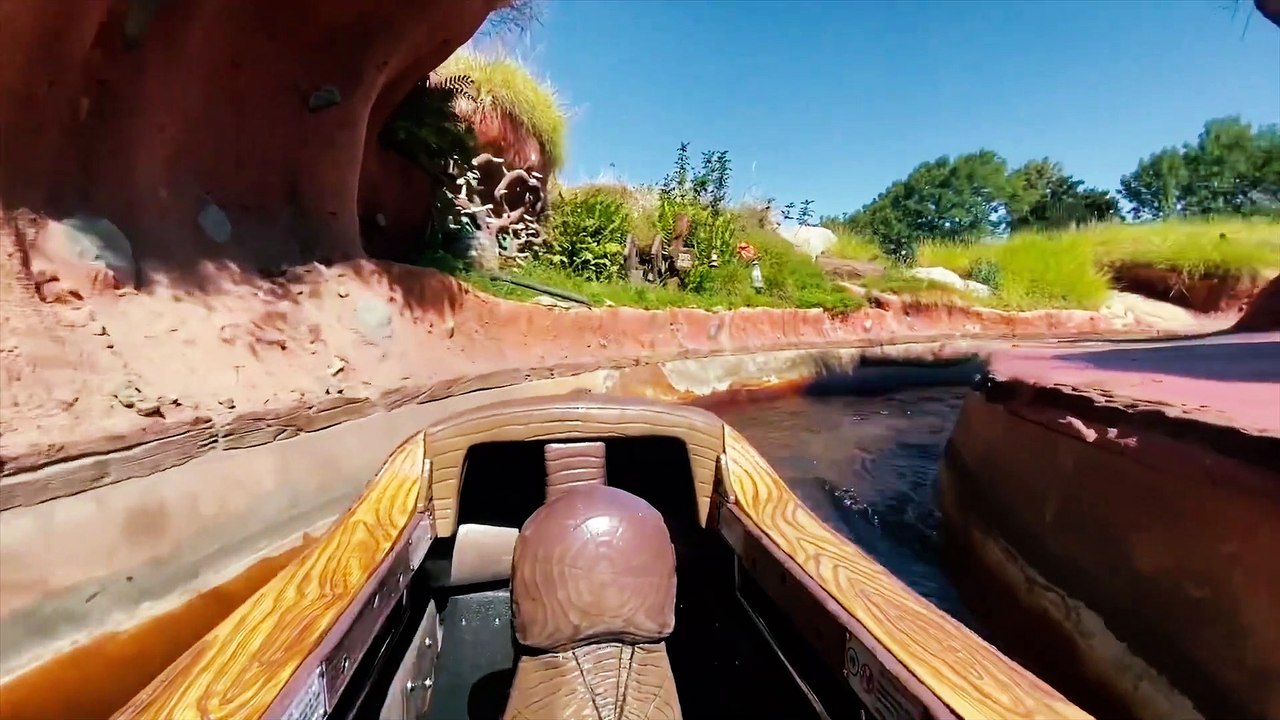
xmin=111 ymin=433 xmax=425 ymax=720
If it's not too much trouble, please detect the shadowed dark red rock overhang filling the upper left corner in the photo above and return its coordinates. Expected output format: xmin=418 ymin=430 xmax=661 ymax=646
xmin=0 ymin=0 xmax=502 ymax=280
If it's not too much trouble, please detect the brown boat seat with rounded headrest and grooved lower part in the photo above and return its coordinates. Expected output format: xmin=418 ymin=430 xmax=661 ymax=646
xmin=503 ymin=481 xmax=681 ymax=720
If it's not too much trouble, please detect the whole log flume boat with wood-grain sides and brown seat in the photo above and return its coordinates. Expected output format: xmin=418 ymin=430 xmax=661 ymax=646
xmin=115 ymin=393 xmax=1087 ymax=720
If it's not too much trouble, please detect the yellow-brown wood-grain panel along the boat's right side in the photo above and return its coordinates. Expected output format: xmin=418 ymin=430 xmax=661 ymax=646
xmin=724 ymin=425 xmax=1089 ymax=720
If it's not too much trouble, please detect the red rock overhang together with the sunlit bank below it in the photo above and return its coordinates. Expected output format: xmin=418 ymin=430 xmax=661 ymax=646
xmin=0 ymin=0 xmax=1259 ymax=499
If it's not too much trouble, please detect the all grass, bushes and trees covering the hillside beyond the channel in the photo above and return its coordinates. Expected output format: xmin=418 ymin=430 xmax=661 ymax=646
xmin=401 ymin=53 xmax=1280 ymax=314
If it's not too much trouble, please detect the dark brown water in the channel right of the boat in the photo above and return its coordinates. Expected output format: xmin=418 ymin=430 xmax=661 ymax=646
xmin=709 ymin=387 xmax=987 ymax=635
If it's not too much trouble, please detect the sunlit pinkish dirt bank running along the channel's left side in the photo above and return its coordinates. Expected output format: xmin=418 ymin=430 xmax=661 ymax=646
xmin=0 ymin=219 xmax=1228 ymax=509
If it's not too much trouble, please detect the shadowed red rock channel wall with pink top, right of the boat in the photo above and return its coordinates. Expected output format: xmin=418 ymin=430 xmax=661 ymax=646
xmin=940 ymin=333 xmax=1280 ymax=719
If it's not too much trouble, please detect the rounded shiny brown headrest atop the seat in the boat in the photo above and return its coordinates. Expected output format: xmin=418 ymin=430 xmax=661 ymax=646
xmin=511 ymin=486 xmax=676 ymax=652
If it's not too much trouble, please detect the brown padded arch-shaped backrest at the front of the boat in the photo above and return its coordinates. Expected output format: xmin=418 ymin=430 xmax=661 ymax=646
xmin=421 ymin=393 xmax=724 ymax=537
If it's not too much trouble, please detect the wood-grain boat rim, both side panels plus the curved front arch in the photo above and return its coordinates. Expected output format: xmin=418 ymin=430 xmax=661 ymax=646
xmin=115 ymin=396 xmax=1088 ymax=720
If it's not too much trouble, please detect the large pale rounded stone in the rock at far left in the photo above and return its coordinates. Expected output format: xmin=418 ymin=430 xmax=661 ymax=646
xmin=31 ymin=215 xmax=137 ymax=301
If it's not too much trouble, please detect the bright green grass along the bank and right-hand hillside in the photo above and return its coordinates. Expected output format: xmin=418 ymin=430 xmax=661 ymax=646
xmin=428 ymin=212 xmax=1280 ymax=314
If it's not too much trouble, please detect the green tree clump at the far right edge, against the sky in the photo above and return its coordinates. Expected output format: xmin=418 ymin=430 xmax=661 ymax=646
xmin=1120 ymin=115 xmax=1280 ymax=219
